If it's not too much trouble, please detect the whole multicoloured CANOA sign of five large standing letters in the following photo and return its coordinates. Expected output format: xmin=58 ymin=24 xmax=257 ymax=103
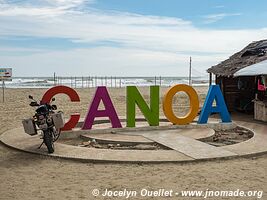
xmin=42 ymin=84 xmax=231 ymax=130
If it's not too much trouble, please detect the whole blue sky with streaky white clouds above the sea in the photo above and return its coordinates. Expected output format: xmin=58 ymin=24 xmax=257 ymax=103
xmin=0 ymin=0 xmax=267 ymax=76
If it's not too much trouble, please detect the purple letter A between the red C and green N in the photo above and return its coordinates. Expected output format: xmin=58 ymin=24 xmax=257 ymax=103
xmin=82 ymin=86 xmax=122 ymax=129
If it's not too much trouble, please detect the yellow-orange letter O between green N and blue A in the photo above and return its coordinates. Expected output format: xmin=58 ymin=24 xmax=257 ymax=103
xmin=163 ymin=84 xmax=199 ymax=125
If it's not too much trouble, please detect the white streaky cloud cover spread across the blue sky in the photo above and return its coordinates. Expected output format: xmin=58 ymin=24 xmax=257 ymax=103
xmin=0 ymin=0 xmax=267 ymax=76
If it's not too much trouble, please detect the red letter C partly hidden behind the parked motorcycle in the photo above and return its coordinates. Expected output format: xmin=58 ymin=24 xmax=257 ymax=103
xmin=42 ymin=86 xmax=80 ymax=131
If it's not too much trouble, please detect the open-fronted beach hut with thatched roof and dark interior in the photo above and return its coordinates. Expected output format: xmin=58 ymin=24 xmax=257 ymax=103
xmin=207 ymin=40 xmax=267 ymax=112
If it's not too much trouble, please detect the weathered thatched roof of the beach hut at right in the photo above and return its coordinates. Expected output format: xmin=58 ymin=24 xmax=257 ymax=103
xmin=207 ymin=39 xmax=267 ymax=76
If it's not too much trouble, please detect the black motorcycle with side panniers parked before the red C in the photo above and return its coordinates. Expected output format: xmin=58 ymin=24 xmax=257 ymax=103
xmin=23 ymin=95 xmax=64 ymax=153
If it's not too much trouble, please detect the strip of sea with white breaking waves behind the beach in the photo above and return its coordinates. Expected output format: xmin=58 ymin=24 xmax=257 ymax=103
xmin=5 ymin=76 xmax=209 ymax=88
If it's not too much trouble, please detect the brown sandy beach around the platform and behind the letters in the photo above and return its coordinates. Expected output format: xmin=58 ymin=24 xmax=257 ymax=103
xmin=0 ymin=87 xmax=267 ymax=200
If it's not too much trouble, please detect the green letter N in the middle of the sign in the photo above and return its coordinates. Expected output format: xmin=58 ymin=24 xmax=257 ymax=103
xmin=127 ymin=86 xmax=159 ymax=127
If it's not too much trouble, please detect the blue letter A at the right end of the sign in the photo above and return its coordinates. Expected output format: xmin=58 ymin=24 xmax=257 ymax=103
xmin=198 ymin=85 xmax=231 ymax=124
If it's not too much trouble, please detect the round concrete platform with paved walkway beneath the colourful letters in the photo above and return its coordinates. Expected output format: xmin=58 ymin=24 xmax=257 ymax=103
xmin=0 ymin=121 xmax=267 ymax=163
